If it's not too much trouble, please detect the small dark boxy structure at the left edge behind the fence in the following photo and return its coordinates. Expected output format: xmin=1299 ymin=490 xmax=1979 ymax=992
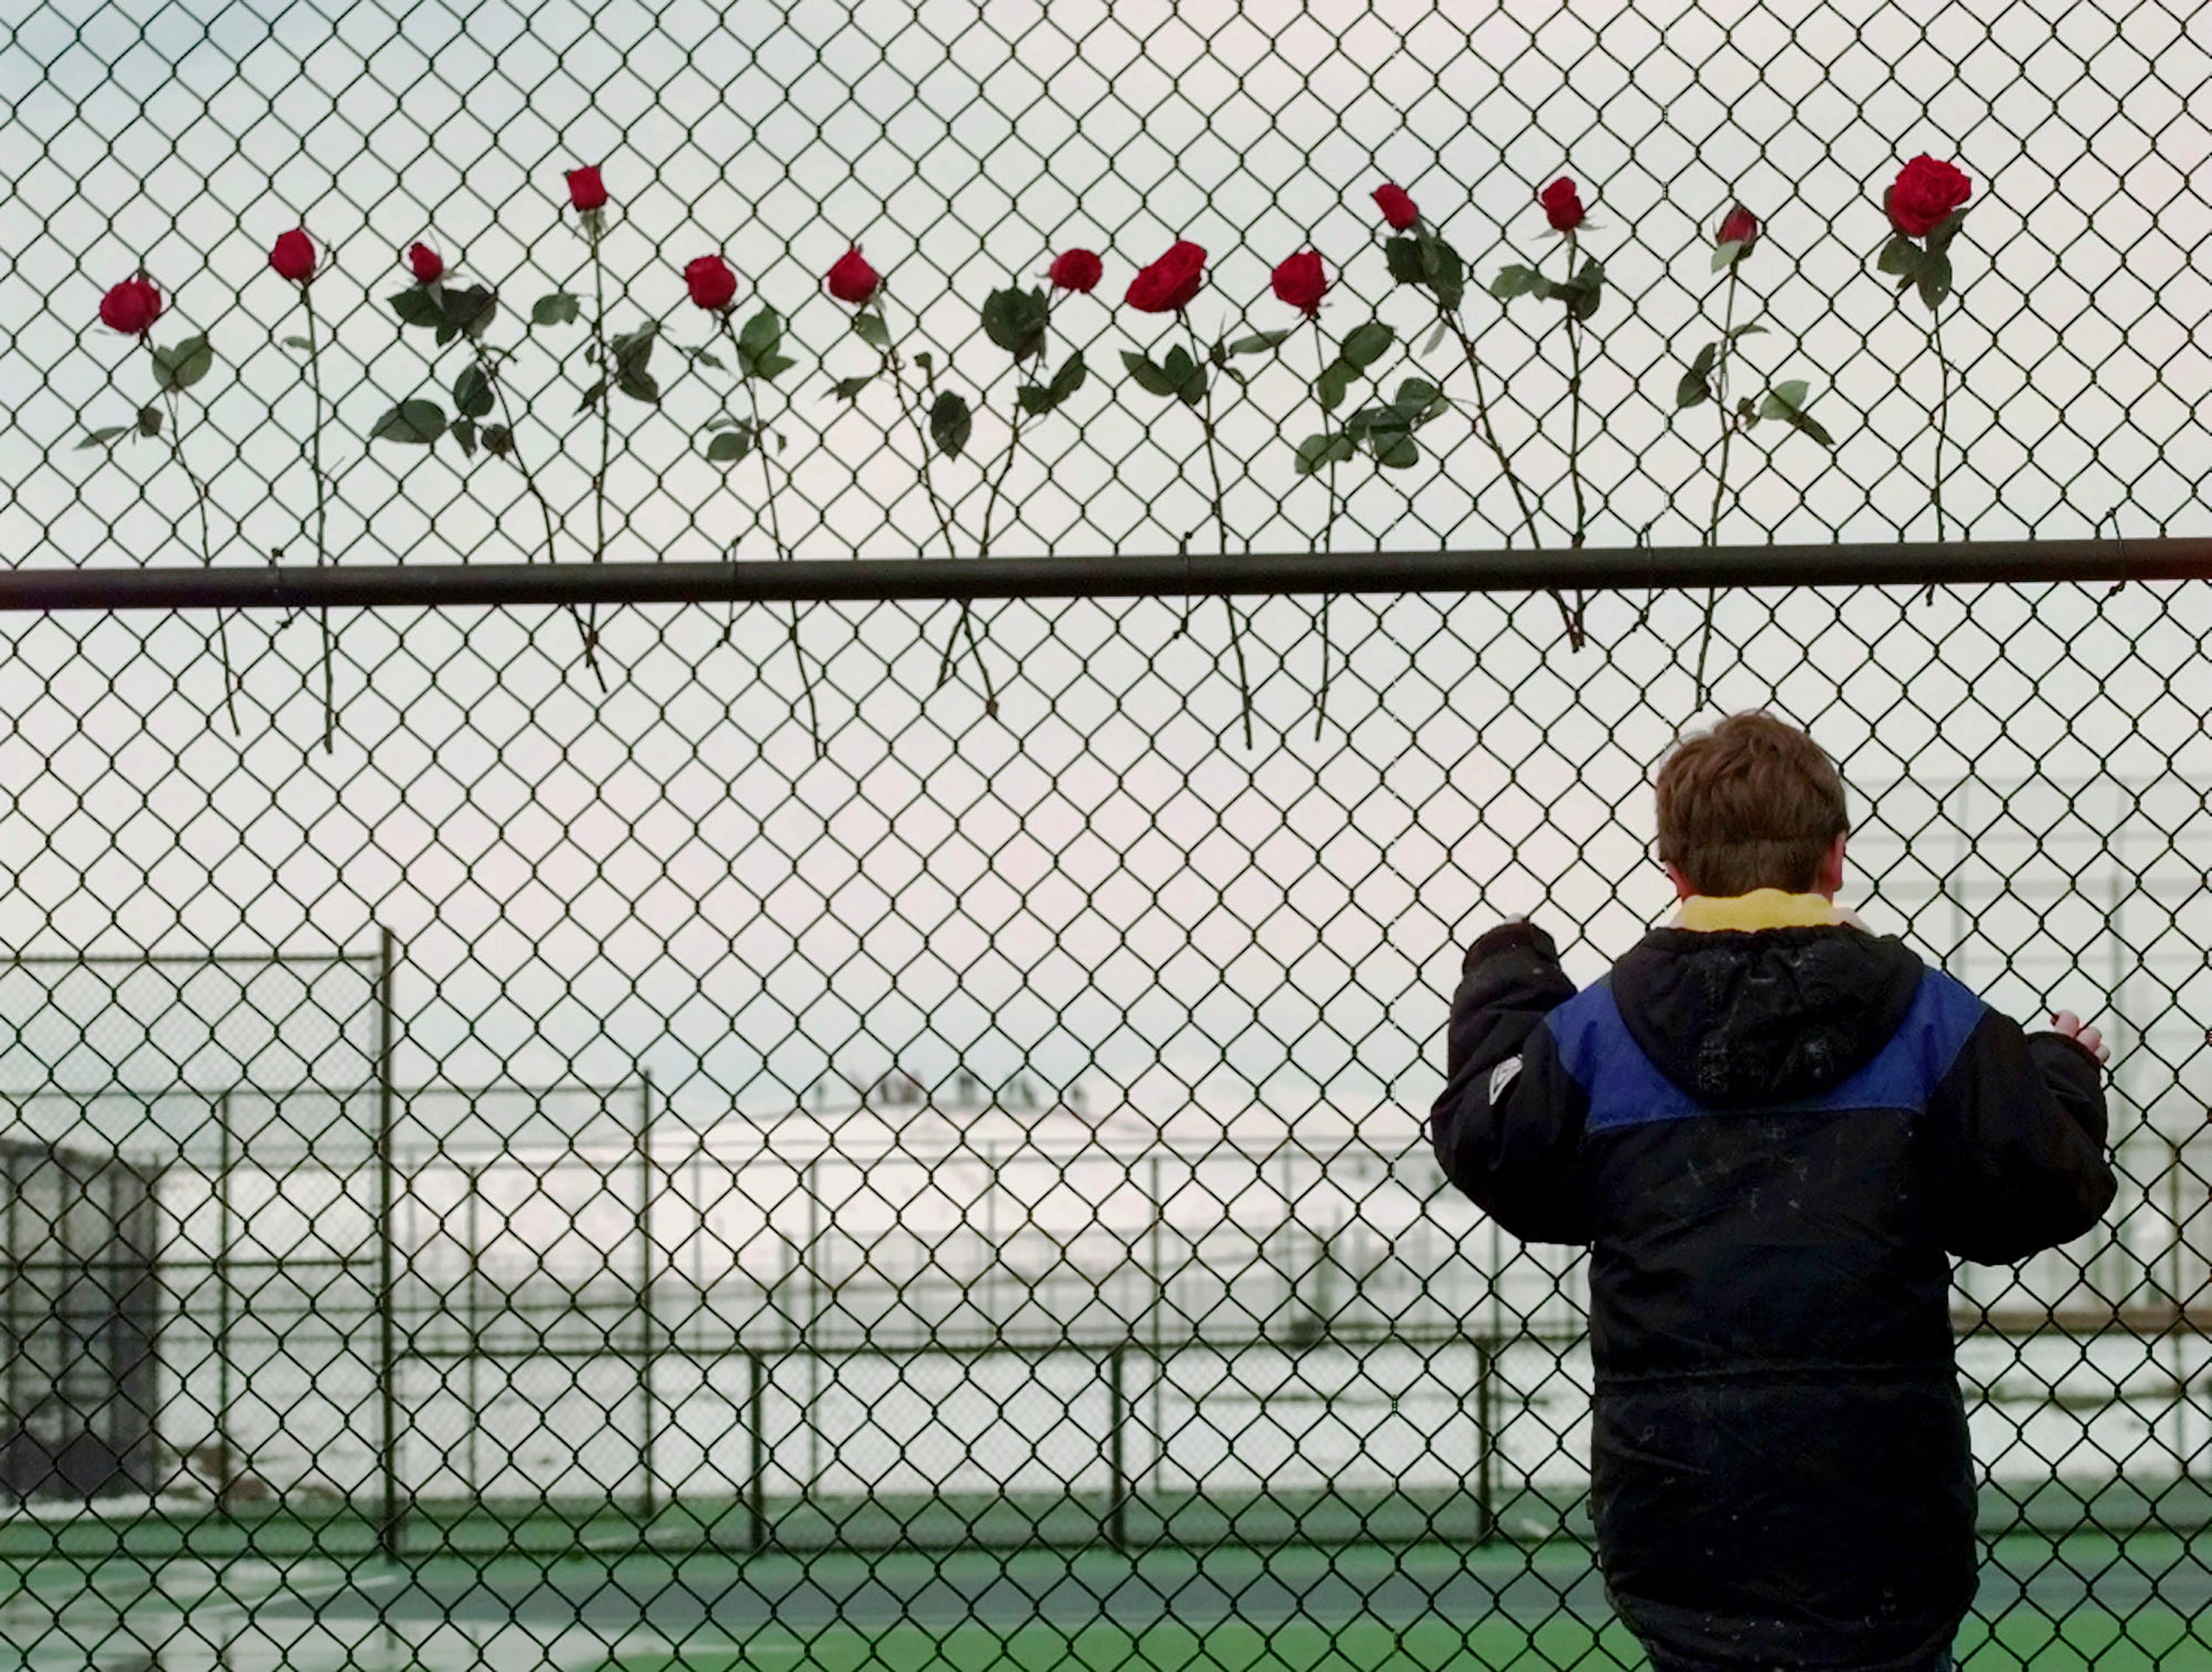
xmin=0 ymin=1139 xmax=159 ymax=1502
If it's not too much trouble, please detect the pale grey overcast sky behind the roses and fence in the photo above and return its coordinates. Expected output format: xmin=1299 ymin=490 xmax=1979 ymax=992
xmin=0 ymin=0 xmax=2212 ymax=1176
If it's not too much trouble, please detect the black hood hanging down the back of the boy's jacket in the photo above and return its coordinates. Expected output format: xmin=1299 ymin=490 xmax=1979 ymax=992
xmin=1613 ymin=924 xmax=1924 ymax=1108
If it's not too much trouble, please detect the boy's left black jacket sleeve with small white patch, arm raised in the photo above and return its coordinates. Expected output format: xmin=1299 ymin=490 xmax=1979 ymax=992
xmin=1429 ymin=922 xmax=1590 ymax=1243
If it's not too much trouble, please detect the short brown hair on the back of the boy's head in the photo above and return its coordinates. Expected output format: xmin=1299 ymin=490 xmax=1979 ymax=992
xmin=1659 ymin=710 xmax=1851 ymax=895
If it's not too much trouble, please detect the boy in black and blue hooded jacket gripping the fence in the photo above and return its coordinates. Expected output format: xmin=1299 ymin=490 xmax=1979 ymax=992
xmin=1429 ymin=715 xmax=2115 ymax=1672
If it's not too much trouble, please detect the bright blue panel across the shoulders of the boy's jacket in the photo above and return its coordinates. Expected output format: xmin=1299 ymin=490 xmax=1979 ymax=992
xmin=1544 ymin=968 xmax=1984 ymax=1132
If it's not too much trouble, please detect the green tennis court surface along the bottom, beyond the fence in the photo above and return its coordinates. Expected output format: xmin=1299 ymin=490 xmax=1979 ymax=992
xmin=0 ymin=1533 xmax=2212 ymax=1672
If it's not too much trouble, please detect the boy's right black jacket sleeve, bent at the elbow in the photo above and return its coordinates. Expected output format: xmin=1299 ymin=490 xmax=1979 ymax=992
xmin=1929 ymin=1008 xmax=2119 ymax=1265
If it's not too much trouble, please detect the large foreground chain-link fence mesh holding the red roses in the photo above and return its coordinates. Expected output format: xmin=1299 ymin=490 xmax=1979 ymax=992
xmin=0 ymin=0 xmax=2212 ymax=1672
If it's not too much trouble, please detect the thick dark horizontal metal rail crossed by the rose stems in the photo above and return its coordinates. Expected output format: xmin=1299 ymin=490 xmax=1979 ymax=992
xmin=0 ymin=538 xmax=2212 ymax=611
